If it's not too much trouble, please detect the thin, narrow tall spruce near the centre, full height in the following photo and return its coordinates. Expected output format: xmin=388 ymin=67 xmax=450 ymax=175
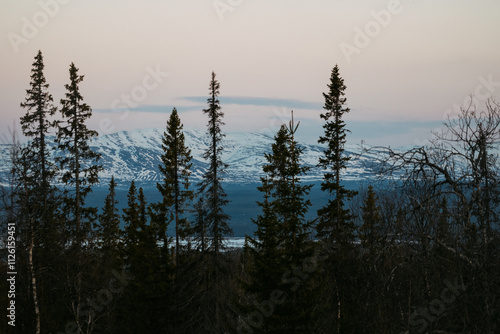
xmin=191 ymin=72 xmax=233 ymax=333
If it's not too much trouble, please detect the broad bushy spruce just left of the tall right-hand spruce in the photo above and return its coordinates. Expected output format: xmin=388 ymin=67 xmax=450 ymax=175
xmin=243 ymin=113 xmax=316 ymax=333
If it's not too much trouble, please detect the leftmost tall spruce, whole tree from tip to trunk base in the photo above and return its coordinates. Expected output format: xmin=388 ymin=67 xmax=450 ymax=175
xmin=16 ymin=51 xmax=60 ymax=333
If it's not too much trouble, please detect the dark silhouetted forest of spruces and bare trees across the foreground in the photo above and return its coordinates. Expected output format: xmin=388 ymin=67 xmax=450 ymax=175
xmin=0 ymin=52 xmax=500 ymax=334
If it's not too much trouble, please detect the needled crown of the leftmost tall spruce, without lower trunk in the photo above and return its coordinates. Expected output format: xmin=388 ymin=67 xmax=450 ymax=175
xmin=16 ymin=51 xmax=58 ymax=251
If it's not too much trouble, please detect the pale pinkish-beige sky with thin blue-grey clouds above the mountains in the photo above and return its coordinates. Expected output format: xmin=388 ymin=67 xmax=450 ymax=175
xmin=0 ymin=0 xmax=500 ymax=146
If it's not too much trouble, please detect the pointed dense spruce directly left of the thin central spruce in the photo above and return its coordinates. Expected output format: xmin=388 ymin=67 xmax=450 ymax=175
xmin=157 ymin=108 xmax=193 ymax=261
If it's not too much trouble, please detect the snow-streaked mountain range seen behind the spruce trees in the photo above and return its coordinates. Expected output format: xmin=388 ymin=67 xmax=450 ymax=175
xmin=0 ymin=128 xmax=384 ymax=183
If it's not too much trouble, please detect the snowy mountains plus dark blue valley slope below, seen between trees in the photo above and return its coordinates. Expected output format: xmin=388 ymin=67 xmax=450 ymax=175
xmin=0 ymin=128 xmax=394 ymax=236
